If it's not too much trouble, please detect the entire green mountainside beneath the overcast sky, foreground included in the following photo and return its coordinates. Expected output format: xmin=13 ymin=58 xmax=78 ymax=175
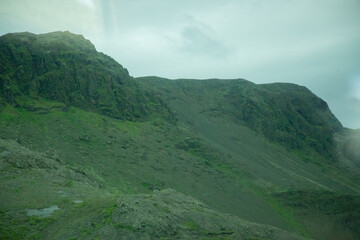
xmin=0 ymin=32 xmax=360 ymax=239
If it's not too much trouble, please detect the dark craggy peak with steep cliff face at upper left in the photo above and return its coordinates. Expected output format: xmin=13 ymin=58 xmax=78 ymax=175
xmin=0 ymin=32 xmax=174 ymax=120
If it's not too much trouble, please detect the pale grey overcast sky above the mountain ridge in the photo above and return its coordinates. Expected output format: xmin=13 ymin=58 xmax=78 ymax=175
xmin=0 ymin=0 xmax=360 ymax=128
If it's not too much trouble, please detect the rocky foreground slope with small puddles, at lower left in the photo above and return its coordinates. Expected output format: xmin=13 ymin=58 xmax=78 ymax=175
xmin=0 ymin=130 xmax=303 ymax=239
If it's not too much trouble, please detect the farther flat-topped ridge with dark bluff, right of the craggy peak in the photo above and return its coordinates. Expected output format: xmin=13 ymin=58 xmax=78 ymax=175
xmin=138 ymin=77 xmax=342 ymax=161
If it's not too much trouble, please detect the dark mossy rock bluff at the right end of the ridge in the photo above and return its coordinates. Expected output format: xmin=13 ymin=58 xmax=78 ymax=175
xmin=225 ymin=83 xmax=342 ymax=159
